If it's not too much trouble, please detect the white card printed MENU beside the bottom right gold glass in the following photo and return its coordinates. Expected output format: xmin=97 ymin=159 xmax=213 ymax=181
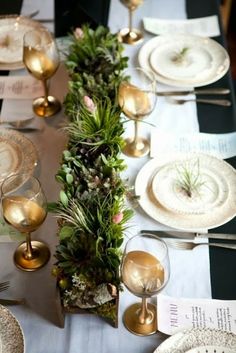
xmin=157 ymin=294 xmax=236 ymax=335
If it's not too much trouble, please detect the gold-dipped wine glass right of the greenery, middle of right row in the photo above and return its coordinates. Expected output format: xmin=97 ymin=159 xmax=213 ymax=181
xmin=118 ymin=68 xmax=157 ymax=157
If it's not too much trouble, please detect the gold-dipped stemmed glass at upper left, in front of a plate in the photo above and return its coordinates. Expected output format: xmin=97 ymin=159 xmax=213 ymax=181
xmin=23 ymin=29 xmax=61 ymax=117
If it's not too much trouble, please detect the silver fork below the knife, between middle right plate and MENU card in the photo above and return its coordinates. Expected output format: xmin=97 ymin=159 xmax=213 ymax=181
xmin=165 ymin=238 xmax=236 ymax=250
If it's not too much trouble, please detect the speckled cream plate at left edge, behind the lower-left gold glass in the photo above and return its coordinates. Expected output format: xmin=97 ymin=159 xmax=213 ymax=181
xmin=0 ymin=128 xmax=38 ymax=183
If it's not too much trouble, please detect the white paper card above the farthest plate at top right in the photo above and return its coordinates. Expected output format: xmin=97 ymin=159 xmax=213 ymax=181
xmin=143 ymin=15 xmax=220 ymax=37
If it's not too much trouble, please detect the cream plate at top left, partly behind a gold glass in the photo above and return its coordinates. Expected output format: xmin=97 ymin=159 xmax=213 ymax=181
xmin=0 ymin=15 xmax=45 ymax=70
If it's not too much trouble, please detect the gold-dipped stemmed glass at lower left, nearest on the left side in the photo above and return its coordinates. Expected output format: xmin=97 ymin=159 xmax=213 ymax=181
xmin=1 ymin=174 xmax=50 ymax=271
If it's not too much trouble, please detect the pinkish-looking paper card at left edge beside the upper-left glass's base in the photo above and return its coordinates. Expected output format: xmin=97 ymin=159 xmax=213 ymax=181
xmin=0 ymin=76 xmax=43 ymax=99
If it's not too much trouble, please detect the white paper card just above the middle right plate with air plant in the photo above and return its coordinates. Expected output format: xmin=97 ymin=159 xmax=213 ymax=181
xmin=150 ymin=129 xmax=236 ymax=159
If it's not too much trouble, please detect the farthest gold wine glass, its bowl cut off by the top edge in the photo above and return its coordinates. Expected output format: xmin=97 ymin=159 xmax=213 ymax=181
xmin=118 ymin=0 xmax=143 ymax=44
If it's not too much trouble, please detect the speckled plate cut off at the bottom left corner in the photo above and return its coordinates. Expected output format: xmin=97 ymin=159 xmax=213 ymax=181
xmin=0 ymin=305 xmax=25 ymax=353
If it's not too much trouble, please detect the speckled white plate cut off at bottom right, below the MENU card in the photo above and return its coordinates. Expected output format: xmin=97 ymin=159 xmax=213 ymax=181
xmin=154 ymin=329 xmax=236 ymax=353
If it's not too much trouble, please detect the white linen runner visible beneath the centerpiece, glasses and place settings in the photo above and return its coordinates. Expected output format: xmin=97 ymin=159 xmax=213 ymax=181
xmin=0 ymin=0 xmax=211 ymax=353
